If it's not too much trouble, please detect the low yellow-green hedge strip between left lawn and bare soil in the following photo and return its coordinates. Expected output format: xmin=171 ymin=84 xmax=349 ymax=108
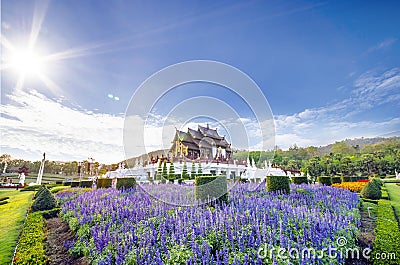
xmin=14 ymin=212 xmax=47 ymax=265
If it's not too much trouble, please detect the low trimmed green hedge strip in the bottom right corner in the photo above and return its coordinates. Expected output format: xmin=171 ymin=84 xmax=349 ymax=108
xmin=371 ymin=200 xmax=400 ymax=265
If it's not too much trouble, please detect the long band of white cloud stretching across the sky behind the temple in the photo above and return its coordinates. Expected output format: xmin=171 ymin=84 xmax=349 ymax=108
xmin=0 ymin=68 xmax=400 ymax=163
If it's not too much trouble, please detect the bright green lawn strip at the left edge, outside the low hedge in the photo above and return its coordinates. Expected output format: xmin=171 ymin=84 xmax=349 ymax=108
xmin=0 ymin=190 xmax=33 ymax=264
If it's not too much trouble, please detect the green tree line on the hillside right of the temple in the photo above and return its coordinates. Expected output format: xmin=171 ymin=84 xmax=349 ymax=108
xmin=234 ymin=138 xmax=400 ymax=176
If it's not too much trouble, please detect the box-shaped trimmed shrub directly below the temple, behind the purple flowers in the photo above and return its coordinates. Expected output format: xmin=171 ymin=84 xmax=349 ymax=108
xmin=194 ymin=175 xmax=228 ymax=203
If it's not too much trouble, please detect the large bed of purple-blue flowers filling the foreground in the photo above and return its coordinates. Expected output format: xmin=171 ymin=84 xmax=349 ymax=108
xmin=56 ymin=184 xmax=359 ymax=264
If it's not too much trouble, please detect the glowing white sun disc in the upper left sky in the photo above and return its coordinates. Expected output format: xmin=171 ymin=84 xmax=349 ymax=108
xmin=10 ymin=49 xmax=45 ymax=76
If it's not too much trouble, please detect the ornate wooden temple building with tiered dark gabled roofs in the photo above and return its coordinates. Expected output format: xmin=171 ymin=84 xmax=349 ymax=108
xmin=170 ymin=124 xmax=232 ymax=161
